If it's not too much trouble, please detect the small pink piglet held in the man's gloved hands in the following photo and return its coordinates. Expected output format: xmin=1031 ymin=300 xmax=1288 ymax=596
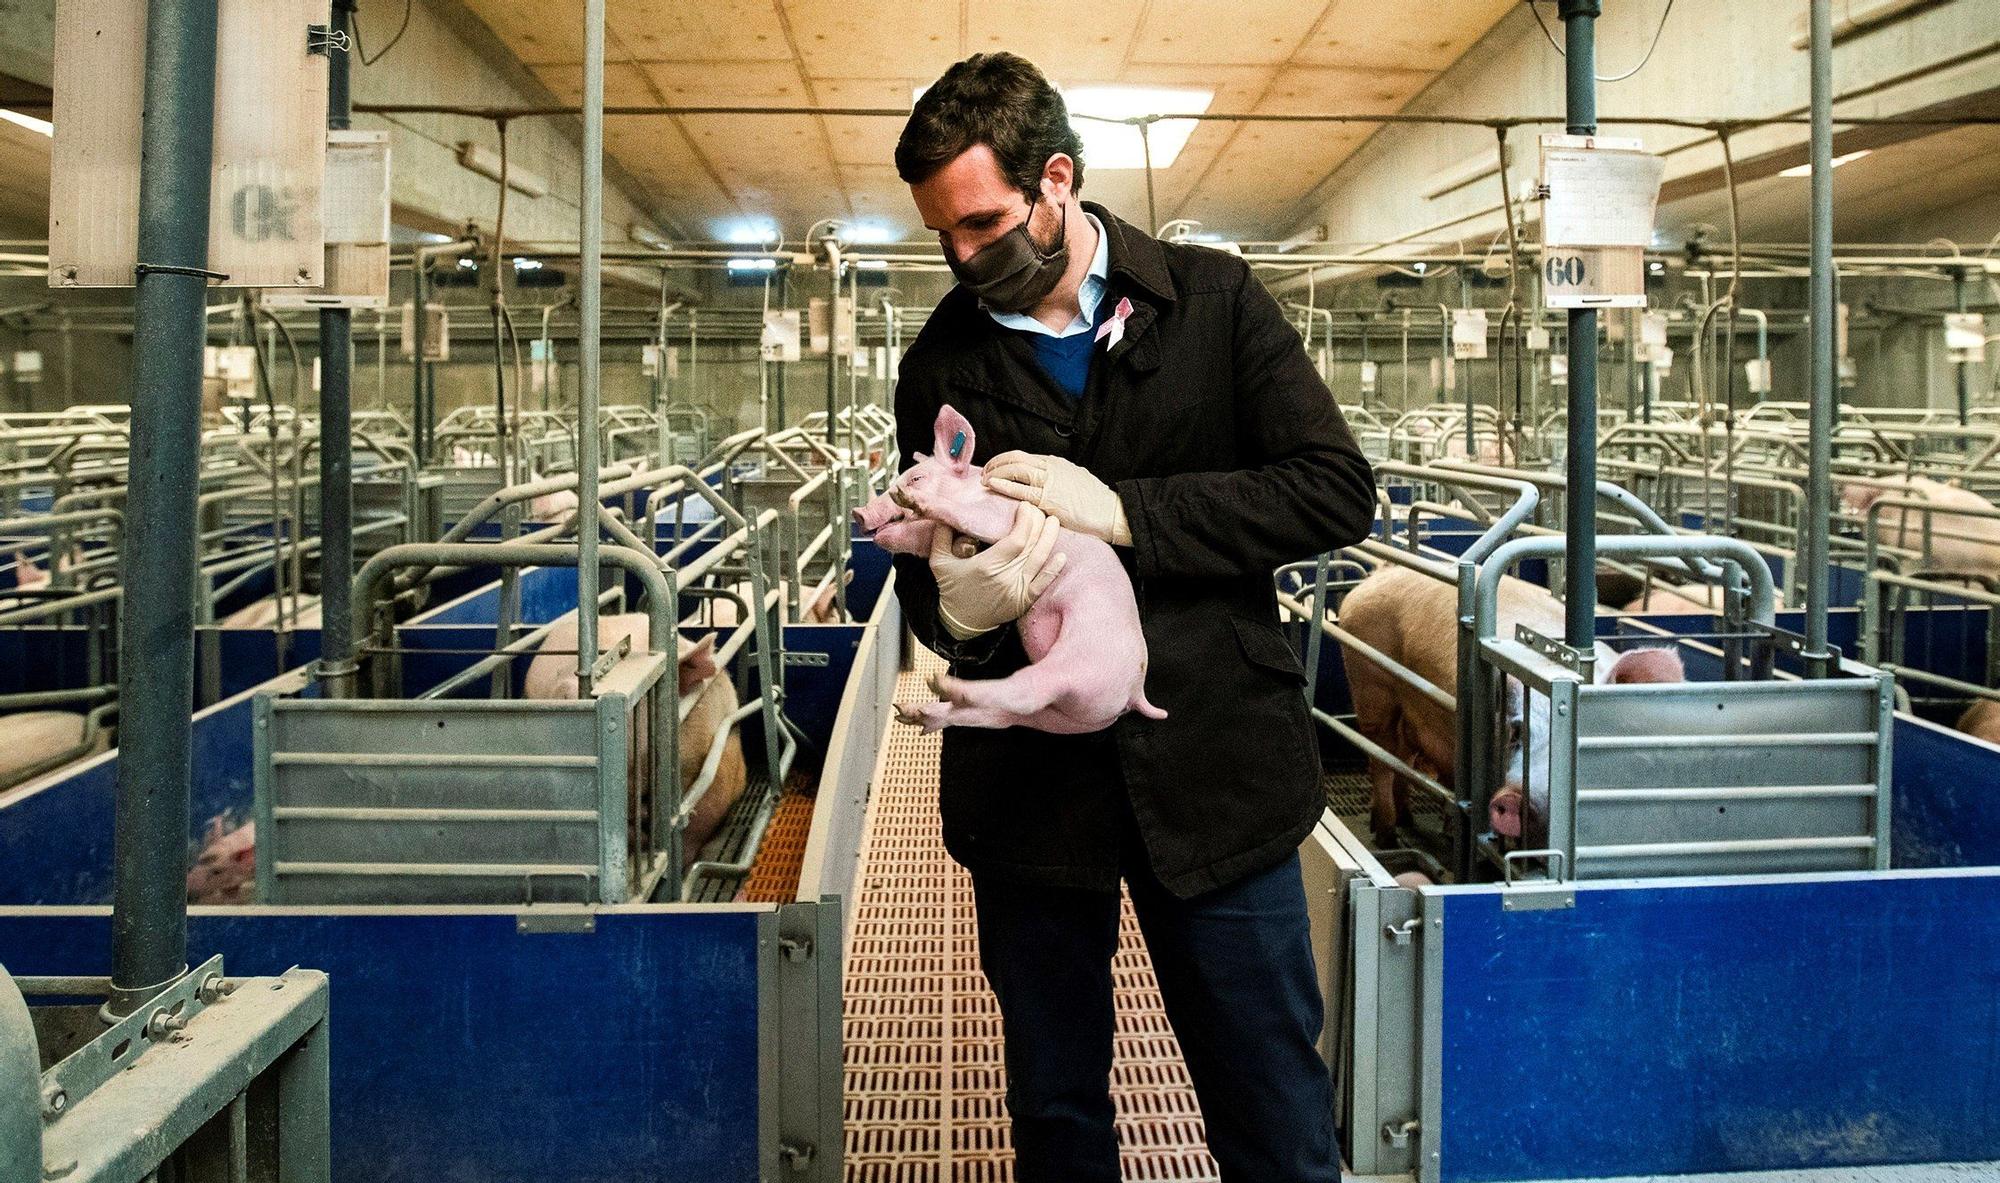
xmin=854 ymin=406 xmax=1166 ymax=735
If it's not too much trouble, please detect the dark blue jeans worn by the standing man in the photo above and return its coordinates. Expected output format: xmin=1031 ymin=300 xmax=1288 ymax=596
xmin=974 ymin=807 xmax=1340 ymax=1183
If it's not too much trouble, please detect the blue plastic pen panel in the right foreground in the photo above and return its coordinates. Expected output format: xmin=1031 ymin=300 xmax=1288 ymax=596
xmin=1428 ymin=871 xmax=2000 ymax=1183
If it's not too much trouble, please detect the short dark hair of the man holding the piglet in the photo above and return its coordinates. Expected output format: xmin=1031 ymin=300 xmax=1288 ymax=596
xmin=896 ymin=52 xmax=1084 ymax=196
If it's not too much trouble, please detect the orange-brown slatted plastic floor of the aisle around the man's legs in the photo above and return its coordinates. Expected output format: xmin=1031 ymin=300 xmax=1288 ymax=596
xmin=844 ymin=651 xmax=1216 ymax=1183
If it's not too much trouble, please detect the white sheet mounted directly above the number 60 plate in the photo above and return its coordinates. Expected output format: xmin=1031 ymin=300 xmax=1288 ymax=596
xmin=1542 ymin=136 xmax=1666 ymax=248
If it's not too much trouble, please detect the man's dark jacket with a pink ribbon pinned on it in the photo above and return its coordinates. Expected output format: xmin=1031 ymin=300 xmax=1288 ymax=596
xmin=896 ymin=204 xmax=1374 ymax=897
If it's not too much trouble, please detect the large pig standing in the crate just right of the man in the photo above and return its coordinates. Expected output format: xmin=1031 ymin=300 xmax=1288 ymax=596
xmin=1340 ymin=564 xmax=1686 ymax=847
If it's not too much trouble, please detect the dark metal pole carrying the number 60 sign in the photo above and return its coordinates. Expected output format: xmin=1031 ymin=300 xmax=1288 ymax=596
xmin=1558 ymin=0 xmax=1602 ymax=653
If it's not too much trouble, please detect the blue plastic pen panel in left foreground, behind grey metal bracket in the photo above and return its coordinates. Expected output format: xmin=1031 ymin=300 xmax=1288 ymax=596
xmin=0 ymin=907 xmax=760 ymax=1183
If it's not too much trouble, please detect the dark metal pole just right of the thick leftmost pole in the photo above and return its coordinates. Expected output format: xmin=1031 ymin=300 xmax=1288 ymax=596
xmin=318 ymin=0 xmax=356 ymax=697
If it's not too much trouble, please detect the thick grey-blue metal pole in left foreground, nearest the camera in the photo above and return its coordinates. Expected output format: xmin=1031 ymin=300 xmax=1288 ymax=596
xmin=108 ymin=0 xmax=216 ymax=1015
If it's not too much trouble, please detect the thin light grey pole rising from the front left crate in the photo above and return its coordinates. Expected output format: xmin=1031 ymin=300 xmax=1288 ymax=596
xmin=576 ymin=0 xmax=604 ymax=697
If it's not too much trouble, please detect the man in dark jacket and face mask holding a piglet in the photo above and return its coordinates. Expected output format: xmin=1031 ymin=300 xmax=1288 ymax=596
xmin=896 ymin=54 xmax=1374 ymax=1183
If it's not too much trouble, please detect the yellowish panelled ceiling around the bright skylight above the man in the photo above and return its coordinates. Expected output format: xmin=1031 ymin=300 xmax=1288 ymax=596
xmin=464 ymin=0 xmax=1516 ymax=238
